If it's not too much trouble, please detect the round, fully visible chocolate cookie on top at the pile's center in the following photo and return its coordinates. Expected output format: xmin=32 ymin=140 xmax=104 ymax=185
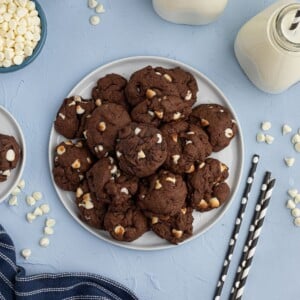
xmin=116 ymin=123 xmax=167 ymax=177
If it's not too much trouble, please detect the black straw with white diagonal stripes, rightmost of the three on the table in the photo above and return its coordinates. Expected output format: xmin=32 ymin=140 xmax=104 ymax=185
xmin=234 ymin=179 xmax=276 ymax=300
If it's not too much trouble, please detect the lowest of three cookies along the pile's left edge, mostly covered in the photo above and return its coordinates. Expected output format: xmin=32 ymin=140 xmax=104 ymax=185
xmin=76 ymin=180 xmax=107 ymax=229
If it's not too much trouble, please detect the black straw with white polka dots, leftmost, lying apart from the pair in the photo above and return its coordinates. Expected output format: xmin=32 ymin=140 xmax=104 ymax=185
xmin=213 ymin=154 xmax=259 ymax=300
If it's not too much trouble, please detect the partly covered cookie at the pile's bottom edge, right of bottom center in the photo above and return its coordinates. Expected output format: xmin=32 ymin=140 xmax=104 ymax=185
xmin=151 ymin=207 xmax=194 ymax=244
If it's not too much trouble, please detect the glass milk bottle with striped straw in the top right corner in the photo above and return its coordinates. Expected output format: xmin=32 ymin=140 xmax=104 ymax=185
xmin=234 ymin=0 xmax=300 ymax=94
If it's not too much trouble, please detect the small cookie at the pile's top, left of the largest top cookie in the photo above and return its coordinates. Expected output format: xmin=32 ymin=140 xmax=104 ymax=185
xmin=92 ymin=74 xmax=128 ymax=108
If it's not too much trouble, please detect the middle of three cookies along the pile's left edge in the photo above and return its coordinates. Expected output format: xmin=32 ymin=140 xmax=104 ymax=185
xmin=53 ymin=141 xmax=93 ymax=191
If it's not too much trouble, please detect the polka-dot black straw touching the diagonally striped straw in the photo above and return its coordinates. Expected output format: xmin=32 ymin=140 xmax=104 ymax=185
xmin=230 ymin=172 xmax=271 ymax=300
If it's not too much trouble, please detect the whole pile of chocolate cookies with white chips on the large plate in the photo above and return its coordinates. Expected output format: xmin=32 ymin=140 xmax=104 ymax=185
xmin=53 ymin=66 xmax=237 ymax=244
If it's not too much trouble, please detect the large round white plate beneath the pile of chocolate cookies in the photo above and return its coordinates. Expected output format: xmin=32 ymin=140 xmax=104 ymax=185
xmin=49 ymin=56 xmax=244 ymax=250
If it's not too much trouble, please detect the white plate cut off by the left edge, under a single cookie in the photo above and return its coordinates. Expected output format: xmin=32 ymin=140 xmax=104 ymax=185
xmin=0 ymin=106 xmax=26 ymax=203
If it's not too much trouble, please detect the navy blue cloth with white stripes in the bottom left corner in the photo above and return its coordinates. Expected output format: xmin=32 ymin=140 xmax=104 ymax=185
xmin=0 ymin=225 xmax=138 ymax=300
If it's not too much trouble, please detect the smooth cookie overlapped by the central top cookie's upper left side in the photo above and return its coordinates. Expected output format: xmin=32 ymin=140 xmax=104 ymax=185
xmin=83 ymin=103 xmax=131 ymax=158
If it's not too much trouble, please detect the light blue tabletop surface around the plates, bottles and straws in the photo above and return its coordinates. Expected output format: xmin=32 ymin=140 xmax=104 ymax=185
xmin=0 ymin=0 xmax=300 ymax=300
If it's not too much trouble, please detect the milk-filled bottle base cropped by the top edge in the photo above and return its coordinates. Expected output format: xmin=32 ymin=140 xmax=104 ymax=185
xmin=152 ymin=0 xmax=227 ymax=25
